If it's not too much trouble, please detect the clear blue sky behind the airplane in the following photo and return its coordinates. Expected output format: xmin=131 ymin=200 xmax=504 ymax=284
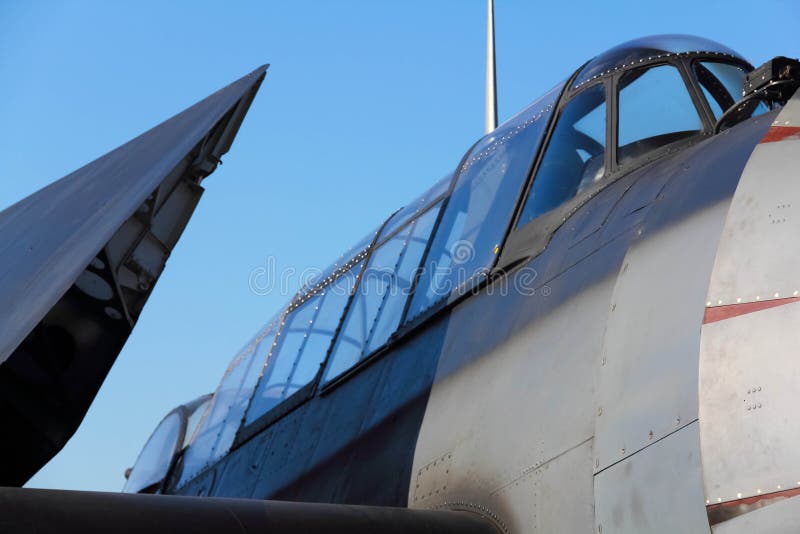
xmin=0 ymin=0 xmax=800 ymax=490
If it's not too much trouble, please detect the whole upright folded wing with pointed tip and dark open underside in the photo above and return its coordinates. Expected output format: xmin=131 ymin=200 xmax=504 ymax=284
xmin=0 ymin=66 xmax=266 ymax=485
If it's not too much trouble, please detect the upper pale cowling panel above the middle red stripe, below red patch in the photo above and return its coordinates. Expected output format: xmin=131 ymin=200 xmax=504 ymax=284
xmin=707 ymin=95 xmax=800 ymax=305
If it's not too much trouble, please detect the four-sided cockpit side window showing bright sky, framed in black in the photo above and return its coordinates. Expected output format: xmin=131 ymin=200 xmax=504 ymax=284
xmin=617 ymin=65 xmax=703 ymax=165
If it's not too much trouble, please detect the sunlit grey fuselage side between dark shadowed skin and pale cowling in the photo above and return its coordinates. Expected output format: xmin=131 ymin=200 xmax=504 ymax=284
xmin=408 ymin=116 xmax=773 ymax=532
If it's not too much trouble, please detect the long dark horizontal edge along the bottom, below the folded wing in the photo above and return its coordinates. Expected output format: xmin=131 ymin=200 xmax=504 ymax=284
xmin=0 ymin=488 xmax=498 ymax=534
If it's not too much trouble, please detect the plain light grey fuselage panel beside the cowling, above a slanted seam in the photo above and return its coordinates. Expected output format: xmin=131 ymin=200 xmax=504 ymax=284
xmin=595 ymin=200 xmax=728 ymax=471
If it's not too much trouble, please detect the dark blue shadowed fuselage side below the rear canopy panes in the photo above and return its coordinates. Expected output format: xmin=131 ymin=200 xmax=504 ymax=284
xmin=195 ymin=315 xmax=456 ymax=506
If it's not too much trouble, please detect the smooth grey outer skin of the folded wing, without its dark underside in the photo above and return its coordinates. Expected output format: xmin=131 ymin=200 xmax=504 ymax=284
xmin=0 ymin=66 xmax=266 ymax=363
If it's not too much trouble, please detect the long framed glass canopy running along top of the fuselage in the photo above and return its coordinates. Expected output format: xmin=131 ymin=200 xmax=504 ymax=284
xmin=130 ymin=35 xmax=766 ymax=494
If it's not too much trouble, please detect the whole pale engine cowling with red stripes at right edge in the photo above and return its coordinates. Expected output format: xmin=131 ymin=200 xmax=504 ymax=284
xmin=699 ymin=95 xmax=800 ymax=533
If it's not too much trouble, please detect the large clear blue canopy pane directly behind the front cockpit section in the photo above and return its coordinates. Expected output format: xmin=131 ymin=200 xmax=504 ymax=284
xmin=408 ymin=84 xmax=563 ymax=319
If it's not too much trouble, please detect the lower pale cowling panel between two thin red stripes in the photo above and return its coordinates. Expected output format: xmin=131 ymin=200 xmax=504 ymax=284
xmin=700 ymin=303 xmax=800 ymax=503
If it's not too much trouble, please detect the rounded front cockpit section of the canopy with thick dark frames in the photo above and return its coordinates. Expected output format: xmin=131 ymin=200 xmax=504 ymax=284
xmin=516 ymin=35 xmax=767 ymax=228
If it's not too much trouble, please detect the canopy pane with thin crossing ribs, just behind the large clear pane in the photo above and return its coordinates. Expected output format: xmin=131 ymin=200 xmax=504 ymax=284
xmin=325 ymin=204 xmax=441 ymax=381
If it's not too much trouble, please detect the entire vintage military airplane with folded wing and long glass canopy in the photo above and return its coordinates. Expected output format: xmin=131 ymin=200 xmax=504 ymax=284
xmin=0 ymin=2 xmax=800 ymax=534
